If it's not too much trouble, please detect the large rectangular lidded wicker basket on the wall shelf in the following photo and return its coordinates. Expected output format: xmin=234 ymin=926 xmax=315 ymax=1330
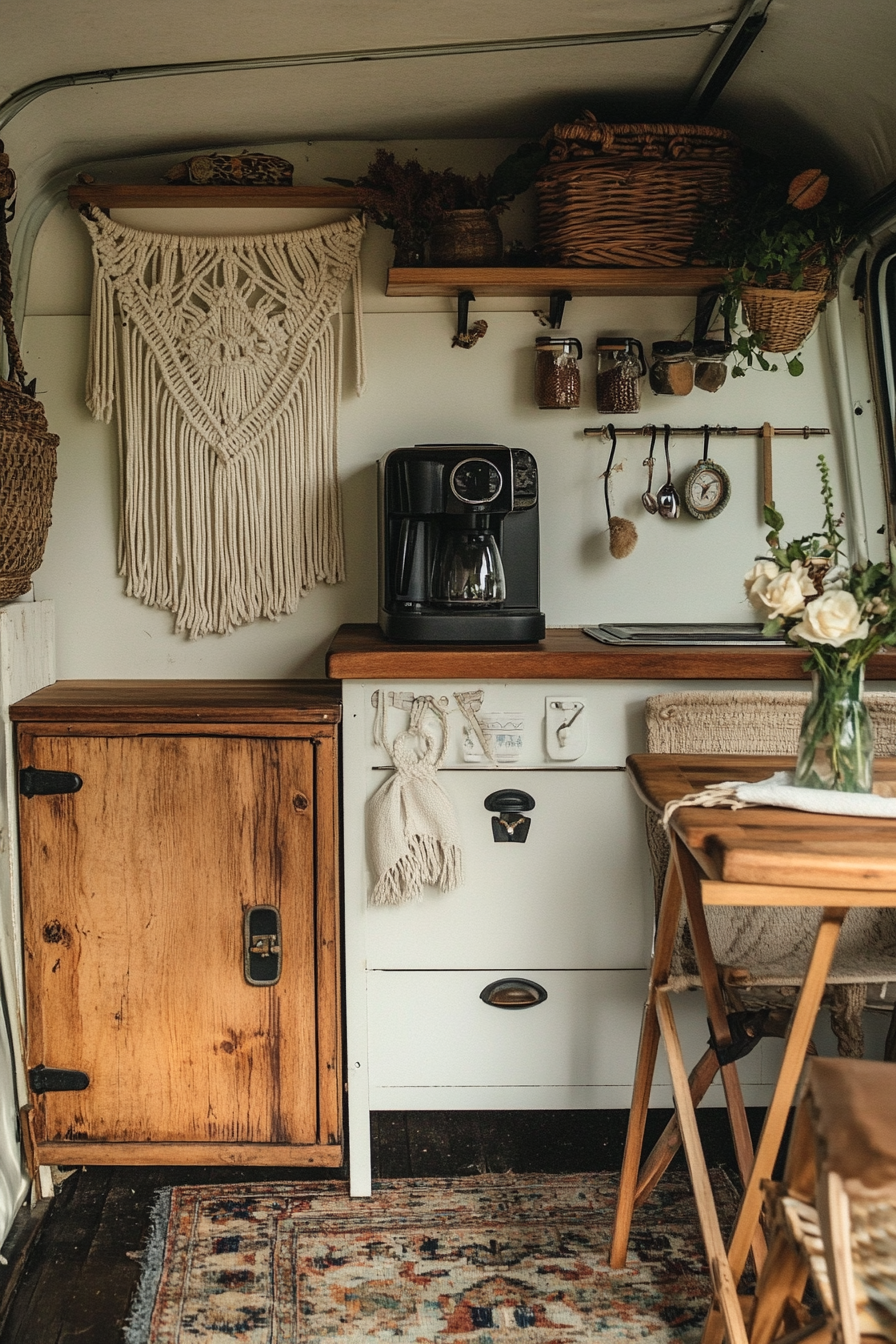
xmin=536 ymin=113 xmax=740 ymax=266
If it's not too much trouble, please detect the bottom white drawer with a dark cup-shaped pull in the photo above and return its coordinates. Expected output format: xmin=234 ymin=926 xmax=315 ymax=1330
xmin=367 ymin=970 xmax=645 ymax=1087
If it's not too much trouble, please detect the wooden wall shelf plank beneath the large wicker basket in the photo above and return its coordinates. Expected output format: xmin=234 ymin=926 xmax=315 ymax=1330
xmin=386 ymin=266 xmax=725 ymax=298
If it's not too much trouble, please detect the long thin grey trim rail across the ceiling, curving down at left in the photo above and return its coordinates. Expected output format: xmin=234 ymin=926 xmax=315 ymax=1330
xmin=0 ymin=20 xmax=737 ymax=130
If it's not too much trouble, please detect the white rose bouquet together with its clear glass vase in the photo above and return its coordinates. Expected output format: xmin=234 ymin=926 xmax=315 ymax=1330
xmin=744 ymin=457 xmax=896 ymax=793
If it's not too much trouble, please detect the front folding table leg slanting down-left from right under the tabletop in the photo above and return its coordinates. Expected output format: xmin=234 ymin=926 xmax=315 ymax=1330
xmin=703 ymin=906 xmax=848 ymax=1344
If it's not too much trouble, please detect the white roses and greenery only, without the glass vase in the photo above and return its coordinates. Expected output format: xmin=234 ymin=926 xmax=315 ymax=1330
xmin=744 ymin=456 xmax=896 ymax=673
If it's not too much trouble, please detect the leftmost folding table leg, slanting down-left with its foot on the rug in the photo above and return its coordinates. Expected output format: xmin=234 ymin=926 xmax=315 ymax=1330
xmin=610 ymin=844 xmax=682 ymax=1269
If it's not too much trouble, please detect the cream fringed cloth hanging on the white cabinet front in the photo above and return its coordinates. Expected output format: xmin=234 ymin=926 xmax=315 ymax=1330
xmin=367 ymin=691 xmax=463 ymax=906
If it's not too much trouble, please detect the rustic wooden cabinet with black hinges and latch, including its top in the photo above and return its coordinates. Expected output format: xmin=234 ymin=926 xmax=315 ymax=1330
xmin=12 ymin=681 xmax=343 ymax=1167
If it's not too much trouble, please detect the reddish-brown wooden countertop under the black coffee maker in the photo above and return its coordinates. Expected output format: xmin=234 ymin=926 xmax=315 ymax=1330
xmin=326 ymin=625 xmax=896 ymax=681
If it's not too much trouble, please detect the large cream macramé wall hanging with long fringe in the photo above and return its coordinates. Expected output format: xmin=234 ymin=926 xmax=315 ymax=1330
xmin=82 ymin=208 xmax=364 ymax=638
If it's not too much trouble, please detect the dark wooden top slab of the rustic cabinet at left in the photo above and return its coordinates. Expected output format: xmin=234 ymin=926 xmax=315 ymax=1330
xmin=9 ymin=680 xmax=343 ymax=723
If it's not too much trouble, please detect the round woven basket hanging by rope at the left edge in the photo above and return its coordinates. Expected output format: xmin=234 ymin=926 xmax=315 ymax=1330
xmin=0 ymin=141 xmax=59 ymax=602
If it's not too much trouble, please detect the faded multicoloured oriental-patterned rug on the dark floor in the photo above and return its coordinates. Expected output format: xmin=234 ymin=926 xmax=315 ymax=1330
xmin=125 ymin=1173 xmax=736 ymax=1344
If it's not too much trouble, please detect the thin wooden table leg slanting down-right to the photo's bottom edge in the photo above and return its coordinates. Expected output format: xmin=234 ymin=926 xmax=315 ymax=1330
xmin=657 ymin=989 xmax=747 ymax=1344
